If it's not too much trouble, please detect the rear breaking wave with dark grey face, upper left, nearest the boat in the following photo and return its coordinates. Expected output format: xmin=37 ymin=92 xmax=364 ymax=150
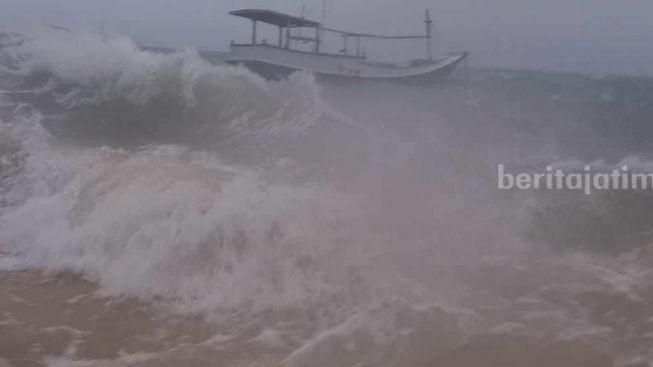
xmin=2 ymin=32 xmax=352 ymax=154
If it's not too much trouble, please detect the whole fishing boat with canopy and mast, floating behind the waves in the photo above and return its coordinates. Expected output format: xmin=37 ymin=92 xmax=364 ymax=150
xmin=228 ymin=9 xmax=469 ymax=81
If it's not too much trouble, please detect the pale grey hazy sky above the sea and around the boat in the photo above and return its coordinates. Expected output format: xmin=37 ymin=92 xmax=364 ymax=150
xmin=0 ymin=0 xmax=653 ymax=75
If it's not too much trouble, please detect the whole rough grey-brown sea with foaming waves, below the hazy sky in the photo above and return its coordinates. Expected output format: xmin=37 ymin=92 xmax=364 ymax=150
xmin=0 ymin=31 xmax=653 ymax=367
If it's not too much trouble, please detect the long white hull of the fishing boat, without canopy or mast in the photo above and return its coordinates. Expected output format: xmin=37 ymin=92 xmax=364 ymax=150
xmin=228 ymin=44 xmax=468 ymax=81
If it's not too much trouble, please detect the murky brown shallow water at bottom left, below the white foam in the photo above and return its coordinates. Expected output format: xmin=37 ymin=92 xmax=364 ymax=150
xmin=0 ymin=272 xmax=283 ymax=367
